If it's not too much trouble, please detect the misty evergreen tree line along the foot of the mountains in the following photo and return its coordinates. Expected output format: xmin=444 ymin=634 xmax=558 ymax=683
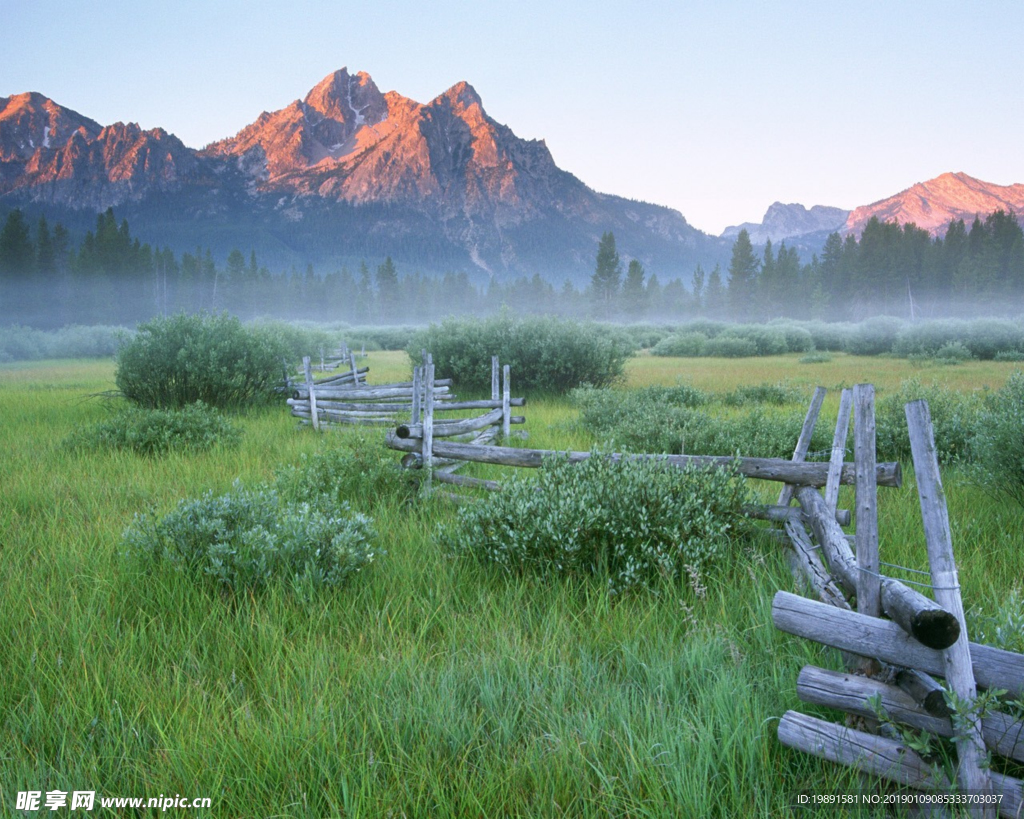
xmin=0 ymin=210 xmax=1024 ymax=328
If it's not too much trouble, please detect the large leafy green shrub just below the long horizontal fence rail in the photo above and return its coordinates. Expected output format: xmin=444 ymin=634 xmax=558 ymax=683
xmin=441 ymin=456 xmax=746 ymax=594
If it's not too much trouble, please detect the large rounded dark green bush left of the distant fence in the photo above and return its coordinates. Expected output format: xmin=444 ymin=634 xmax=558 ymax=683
xmin=115 ymin=313 xmax=288 ymax=408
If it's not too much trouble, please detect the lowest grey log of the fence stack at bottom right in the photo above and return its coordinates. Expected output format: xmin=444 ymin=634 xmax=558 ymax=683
xmin=778 ymin=710 xmax=1024 ymax=819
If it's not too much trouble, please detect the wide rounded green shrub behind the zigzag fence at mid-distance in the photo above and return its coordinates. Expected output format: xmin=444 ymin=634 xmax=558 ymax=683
xmin=409 ymin=313 xmax=635 ymax=393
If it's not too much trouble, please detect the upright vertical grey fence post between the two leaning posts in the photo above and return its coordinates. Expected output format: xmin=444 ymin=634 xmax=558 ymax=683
xmin=853 ymin=384 xmax=882 ymax=617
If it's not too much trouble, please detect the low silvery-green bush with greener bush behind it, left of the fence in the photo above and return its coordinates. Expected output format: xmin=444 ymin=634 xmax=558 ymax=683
xmin=124 ymin=432 xmax=401 ymax=598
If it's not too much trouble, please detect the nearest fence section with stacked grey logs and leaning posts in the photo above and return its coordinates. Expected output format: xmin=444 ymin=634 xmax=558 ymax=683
xmin=772 ymin=385 xmax=1024 ymax=819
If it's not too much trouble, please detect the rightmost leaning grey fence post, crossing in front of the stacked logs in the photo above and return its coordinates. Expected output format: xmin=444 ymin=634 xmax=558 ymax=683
xmin=904 ymin=400 xmax=995 ymax=817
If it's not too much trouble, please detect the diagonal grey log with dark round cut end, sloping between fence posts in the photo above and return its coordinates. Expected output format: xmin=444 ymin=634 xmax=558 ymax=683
xmin=797 ymin=486 xmax=959 ymax=648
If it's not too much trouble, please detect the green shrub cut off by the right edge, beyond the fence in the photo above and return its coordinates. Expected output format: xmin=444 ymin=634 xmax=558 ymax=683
xmin=974 ymin=370 xmax=1024 ymax=506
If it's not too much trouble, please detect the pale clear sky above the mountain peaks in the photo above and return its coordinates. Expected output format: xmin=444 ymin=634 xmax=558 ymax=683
xmin=0 ymin=0 xmax=1024 ymax=233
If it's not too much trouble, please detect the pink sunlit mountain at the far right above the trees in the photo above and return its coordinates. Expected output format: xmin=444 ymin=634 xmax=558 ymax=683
xmin=844 ymin=173 xmax=1024 ymax=234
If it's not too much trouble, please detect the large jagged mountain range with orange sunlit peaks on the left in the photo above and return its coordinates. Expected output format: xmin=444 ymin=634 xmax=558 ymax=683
xmin=0 ymin=69 xmax=728 ymax=283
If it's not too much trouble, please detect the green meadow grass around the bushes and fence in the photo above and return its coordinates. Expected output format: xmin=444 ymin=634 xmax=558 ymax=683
xmin=0 ymin=352 xmax=1024 ymax=818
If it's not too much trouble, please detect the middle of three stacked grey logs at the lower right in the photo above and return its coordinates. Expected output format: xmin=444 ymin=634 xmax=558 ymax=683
xmin=797 ymin=665 xmax=1024 ymax=762
